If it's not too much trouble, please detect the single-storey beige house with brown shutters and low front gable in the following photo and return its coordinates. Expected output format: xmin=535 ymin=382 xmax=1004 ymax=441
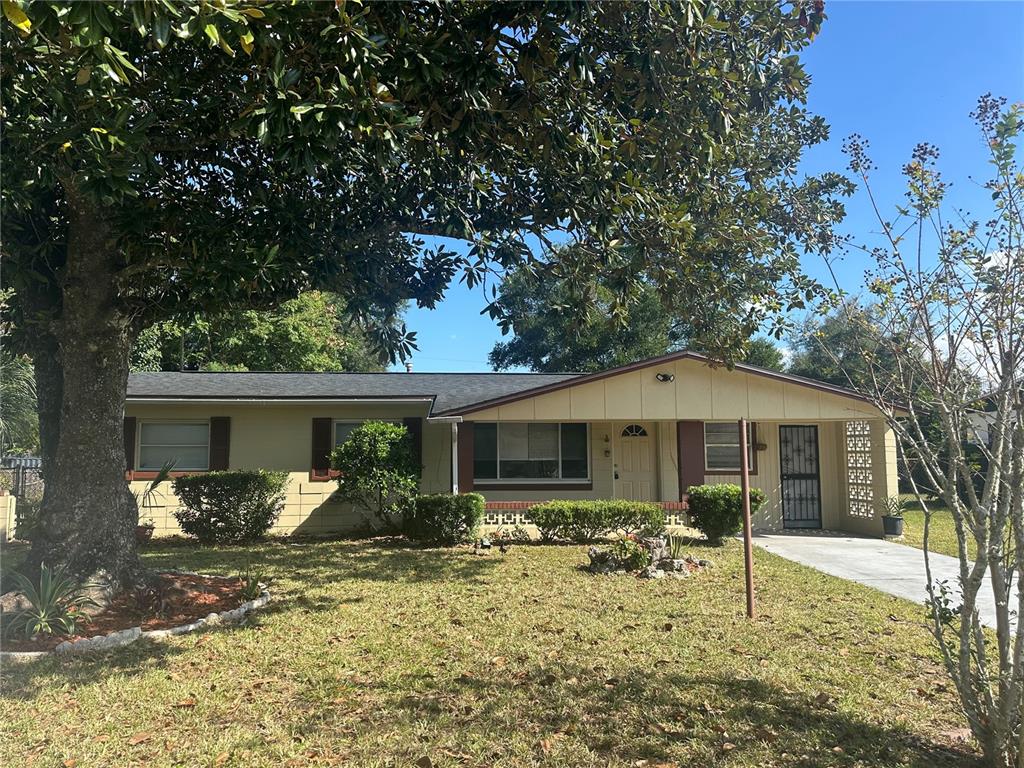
xmin=125 ymin=351 xmax=897 ymax=536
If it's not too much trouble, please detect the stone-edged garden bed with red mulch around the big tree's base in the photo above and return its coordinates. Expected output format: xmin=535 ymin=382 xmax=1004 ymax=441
xmin=0 ymin=570 xmax=270 ymax=660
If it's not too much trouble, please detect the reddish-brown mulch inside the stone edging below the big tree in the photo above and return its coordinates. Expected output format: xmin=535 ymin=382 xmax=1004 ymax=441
xmin=3 ymin=573 xmax=245 ymax=651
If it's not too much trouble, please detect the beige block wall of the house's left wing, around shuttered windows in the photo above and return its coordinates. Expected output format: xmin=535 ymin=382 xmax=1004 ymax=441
xmin=125 ymin=402 xmax=452 ymax=536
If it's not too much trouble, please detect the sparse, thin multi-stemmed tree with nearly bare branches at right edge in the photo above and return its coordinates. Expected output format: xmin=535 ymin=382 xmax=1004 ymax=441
xmin=846 ymin=96 xmax=1024 ymax=766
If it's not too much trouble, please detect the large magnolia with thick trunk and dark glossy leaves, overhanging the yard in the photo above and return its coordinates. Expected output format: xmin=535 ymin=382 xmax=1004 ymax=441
xmin=0 ymin=0 xmax=844 ymax=588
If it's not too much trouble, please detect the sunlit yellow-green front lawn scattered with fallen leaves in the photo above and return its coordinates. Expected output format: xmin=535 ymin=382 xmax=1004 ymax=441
xmin=0 ymin=542 xmax=975 ymax=768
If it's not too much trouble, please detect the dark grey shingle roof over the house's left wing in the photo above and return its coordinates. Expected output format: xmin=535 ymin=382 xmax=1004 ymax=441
xmin=128 ymin=372 xmax=580 ymax=413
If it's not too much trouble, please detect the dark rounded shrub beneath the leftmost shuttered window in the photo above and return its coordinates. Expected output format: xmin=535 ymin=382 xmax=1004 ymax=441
xmin=173 ymin=469 xmax=288 ymax=544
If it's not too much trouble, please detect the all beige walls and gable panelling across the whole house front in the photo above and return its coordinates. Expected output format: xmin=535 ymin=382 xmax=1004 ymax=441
xmin=126 ymin=360 xmax=897 ymax=535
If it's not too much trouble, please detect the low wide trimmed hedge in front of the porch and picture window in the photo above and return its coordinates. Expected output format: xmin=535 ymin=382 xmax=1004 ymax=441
xmin=526 ymin=500 xmax=665 ymax=542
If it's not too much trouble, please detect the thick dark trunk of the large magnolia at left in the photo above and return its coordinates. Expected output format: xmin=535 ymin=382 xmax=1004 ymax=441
xmin=30 ymin=195 xmax=143 ymax=596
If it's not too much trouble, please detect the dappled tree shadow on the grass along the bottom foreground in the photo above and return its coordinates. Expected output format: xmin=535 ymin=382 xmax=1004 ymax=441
xmin=299 ymin=665 xmax=981 ymax=768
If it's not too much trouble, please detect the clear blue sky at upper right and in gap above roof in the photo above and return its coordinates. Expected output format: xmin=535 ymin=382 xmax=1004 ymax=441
xmin=393 ymin=0 xmax=1024 ymax=371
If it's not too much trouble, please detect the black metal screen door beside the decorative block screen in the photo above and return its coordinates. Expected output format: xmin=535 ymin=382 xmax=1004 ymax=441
xmin=778 ymin=426 xmax=821 ymax=528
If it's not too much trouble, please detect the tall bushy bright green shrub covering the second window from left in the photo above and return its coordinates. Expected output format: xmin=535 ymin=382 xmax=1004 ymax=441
xmin=331 ymin=421 xmax=422 ymax=531
